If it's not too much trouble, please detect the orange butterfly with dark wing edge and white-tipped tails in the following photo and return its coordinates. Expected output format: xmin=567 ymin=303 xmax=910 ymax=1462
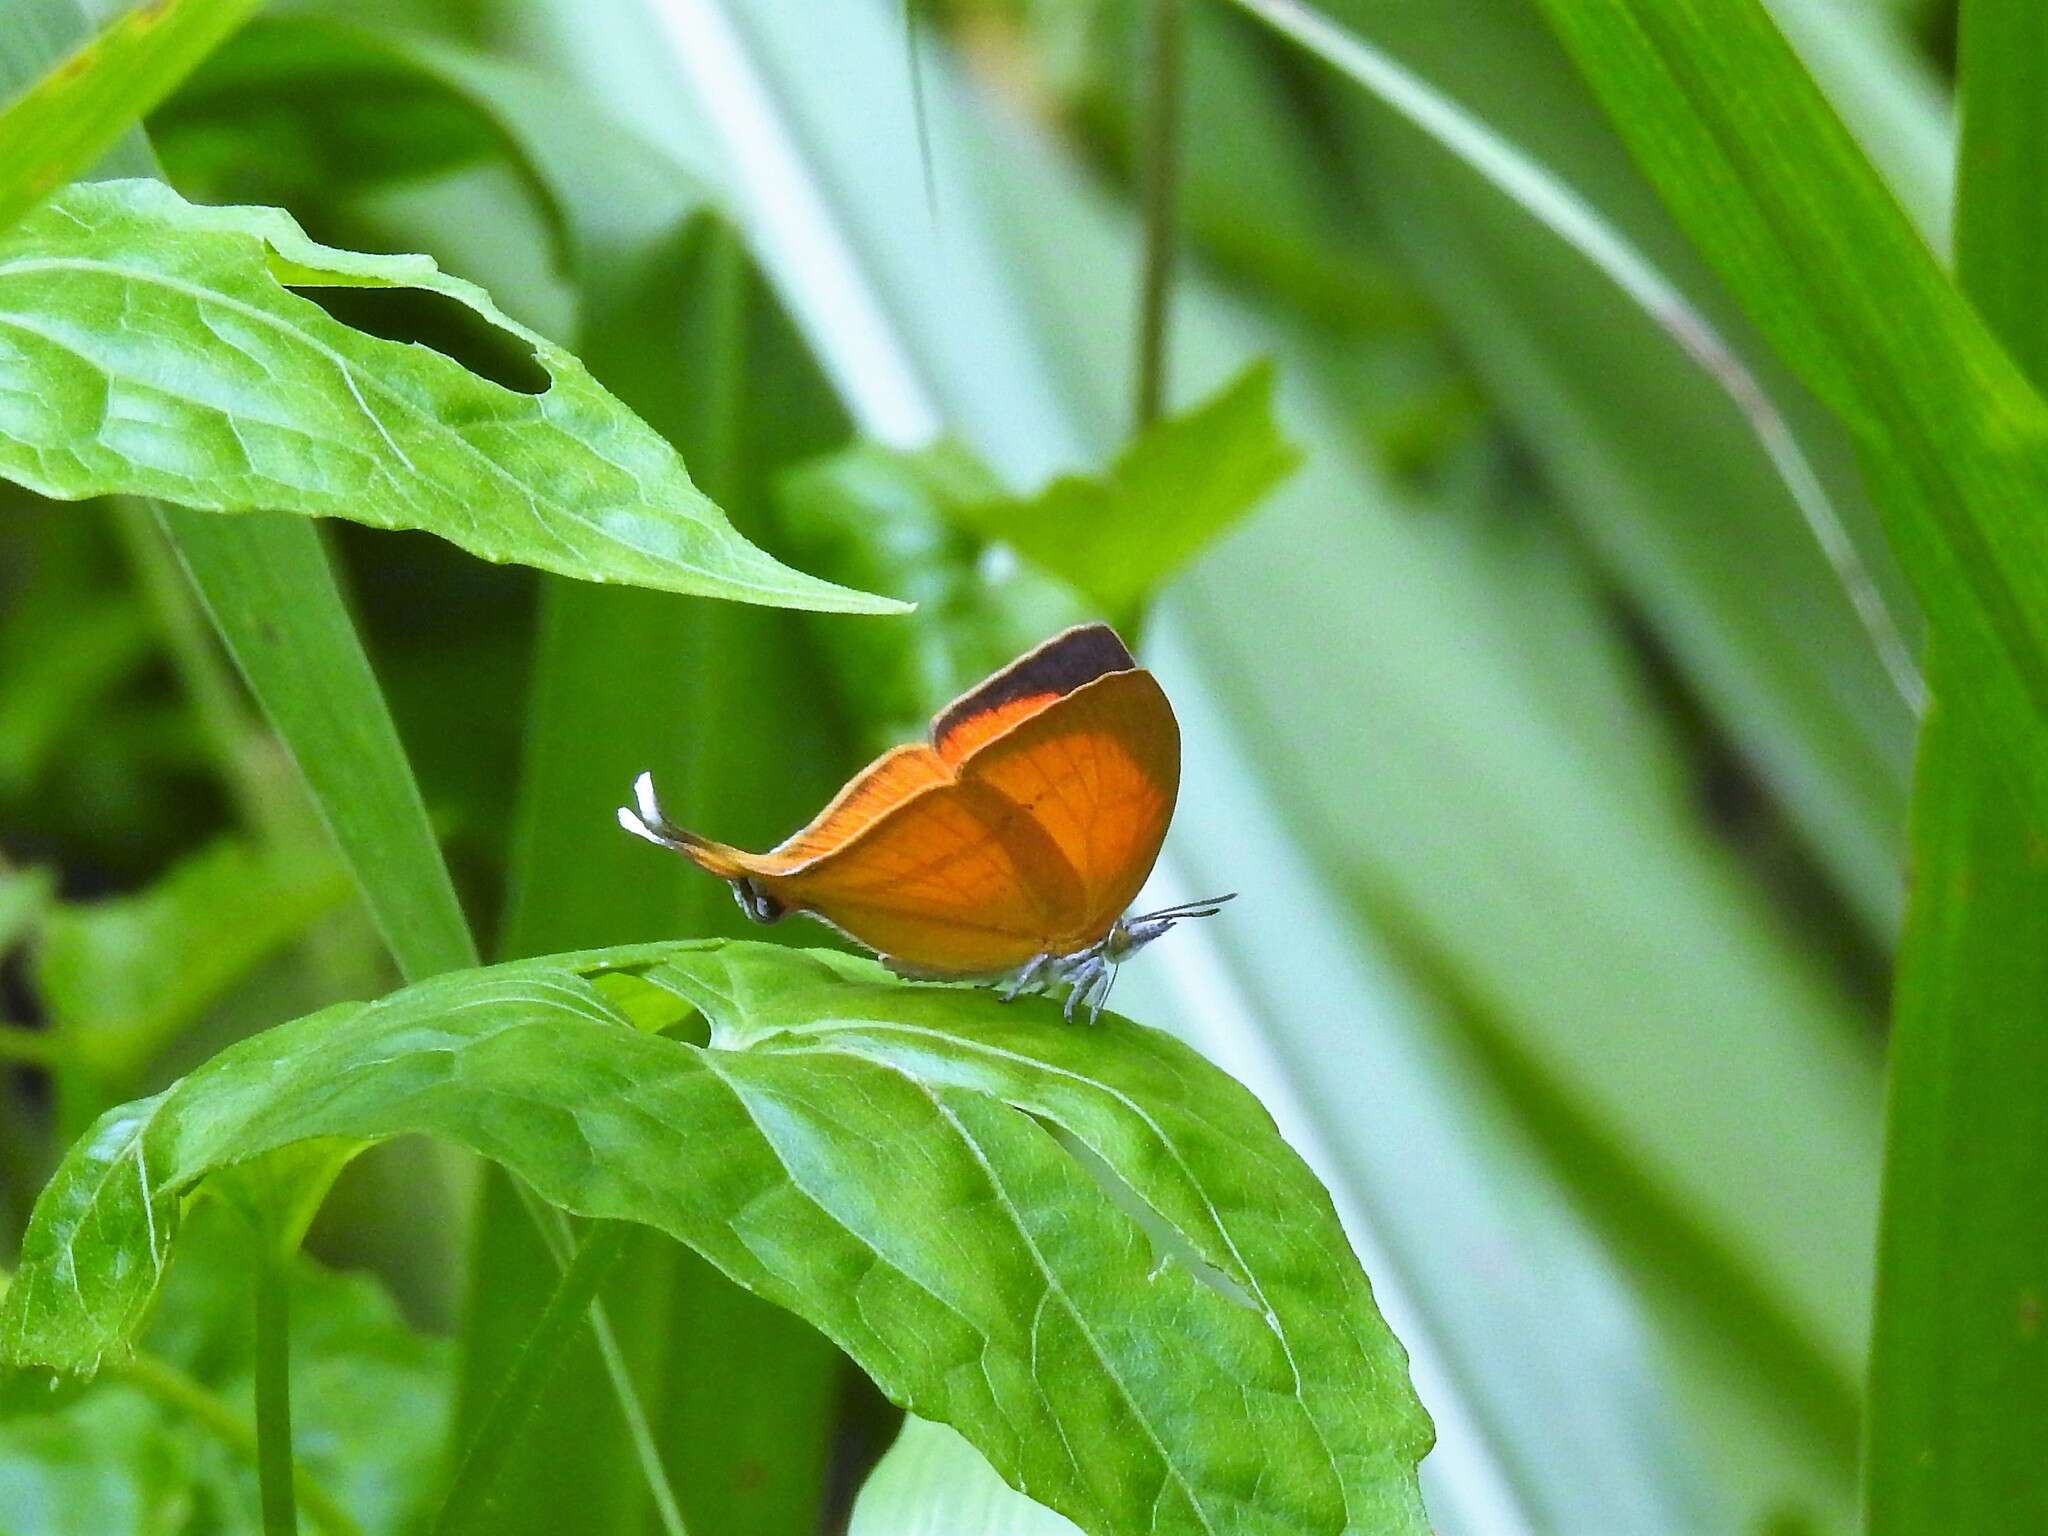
xmin=618 ymin=625 xmax=1231 ymax=1020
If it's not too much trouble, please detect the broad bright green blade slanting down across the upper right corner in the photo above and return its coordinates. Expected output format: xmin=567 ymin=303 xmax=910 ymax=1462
xmin=1542 ymin=0 xmax=2048 ymax=843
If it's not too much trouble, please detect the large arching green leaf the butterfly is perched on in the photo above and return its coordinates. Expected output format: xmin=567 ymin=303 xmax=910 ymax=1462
xmin=0 ymin=942 xmax=1432 ymax=1536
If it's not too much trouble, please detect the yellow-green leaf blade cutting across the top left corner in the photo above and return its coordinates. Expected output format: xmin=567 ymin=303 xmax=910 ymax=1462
xmin=0 ymin=0 xmax=262 ymax=229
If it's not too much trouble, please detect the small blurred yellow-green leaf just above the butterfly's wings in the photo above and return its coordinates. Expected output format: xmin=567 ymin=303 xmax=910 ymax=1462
xmin=950 ymin=362 xmax=1300 ymax=625
